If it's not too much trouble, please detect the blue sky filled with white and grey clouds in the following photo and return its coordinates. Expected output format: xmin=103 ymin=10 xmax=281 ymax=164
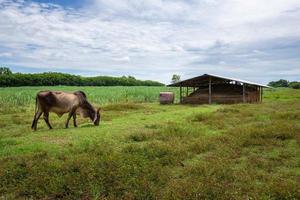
xmin=0 ymin=0 xmax=300 ymax=83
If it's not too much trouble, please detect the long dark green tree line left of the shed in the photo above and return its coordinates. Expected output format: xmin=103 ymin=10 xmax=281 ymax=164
xmin=0 ymin=67 xmax=164 ymax=87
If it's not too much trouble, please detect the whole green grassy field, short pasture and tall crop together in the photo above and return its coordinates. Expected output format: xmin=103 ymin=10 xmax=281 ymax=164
xmin=0 ymin=87 xmax=300 ymax=199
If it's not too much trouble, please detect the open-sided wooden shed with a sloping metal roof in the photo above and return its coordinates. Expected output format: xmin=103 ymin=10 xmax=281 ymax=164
xmin=168 ymin=74 xmax=268 ymax=104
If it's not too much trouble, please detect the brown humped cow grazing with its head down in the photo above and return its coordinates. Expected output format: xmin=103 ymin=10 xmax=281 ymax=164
xmin=31 ymin=91 xmax=100 ymax=130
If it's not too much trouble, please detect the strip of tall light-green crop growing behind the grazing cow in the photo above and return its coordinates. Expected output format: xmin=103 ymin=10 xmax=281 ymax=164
xmin=0 ymin=86 xmax=178 ymax=108
